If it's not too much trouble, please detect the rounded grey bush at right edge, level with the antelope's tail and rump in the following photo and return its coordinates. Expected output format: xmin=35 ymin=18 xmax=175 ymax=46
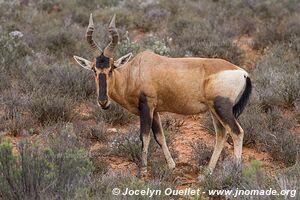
xmin=253 ymin=44 xmax=300 ymax=107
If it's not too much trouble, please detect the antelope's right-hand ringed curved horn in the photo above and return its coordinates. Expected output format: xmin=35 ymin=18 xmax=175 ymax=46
xmin=104 ymin=14 xmax=119 ymax=58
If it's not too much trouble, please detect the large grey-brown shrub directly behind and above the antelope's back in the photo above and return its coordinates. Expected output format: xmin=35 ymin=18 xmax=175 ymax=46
xmin=170 ymin=19 xmax=243 ymax=64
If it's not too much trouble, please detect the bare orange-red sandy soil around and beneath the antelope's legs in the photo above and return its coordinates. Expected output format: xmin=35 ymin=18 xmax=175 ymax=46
xmin=90 ymin=114 xmax=283 ymax=186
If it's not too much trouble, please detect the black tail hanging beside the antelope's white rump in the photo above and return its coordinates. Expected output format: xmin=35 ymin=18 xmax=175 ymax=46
xmin=232 ymin=77 xmax=252 ymax=118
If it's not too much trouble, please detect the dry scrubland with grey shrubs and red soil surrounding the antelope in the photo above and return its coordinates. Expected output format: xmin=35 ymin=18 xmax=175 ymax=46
xmin=0 ymin=0 xmax=300 ymax=200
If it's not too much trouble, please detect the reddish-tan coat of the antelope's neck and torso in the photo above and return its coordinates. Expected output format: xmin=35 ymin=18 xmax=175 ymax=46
xmin=108 ymin=51 xmax=247 ymax=115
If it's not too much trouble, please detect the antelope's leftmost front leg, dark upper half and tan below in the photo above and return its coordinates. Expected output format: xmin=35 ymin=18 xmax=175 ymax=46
xmin=139 ymin=95 xmax=153 ymax=177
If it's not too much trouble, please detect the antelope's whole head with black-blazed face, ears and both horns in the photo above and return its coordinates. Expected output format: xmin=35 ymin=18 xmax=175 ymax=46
xmin=74 ymin=14 xmax=132 ymax=109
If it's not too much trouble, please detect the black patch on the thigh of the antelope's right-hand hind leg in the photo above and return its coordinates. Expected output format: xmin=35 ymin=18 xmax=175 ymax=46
xmin=214 ymin=96 xmax=240 ymax=134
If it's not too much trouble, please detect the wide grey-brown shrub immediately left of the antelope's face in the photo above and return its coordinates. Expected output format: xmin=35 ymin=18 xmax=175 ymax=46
xmin=20 ymin=63 xmax=95 ymax=100
